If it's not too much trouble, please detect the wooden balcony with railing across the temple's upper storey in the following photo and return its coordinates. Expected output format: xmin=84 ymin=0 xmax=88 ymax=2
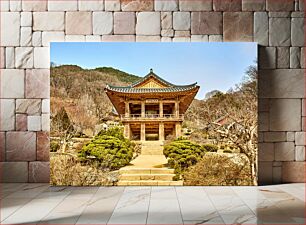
xmin=121 ymin=114 xmax=184 ymax=122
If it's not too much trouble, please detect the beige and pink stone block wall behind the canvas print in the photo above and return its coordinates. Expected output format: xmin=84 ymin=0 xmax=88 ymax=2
xmin=0 ymin=0 xmax=306 ymax=184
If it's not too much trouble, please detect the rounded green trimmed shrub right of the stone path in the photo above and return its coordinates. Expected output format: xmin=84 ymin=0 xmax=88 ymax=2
xmin=164 ymin=139 xmax=205 ymax=180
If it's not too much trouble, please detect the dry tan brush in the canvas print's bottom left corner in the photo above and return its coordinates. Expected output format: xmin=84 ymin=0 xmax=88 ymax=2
xmin=50 ymin=153 xmax=118 ymax=186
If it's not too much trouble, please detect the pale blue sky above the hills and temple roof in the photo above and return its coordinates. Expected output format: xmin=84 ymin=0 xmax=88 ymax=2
xmin=51 ymin=42 xmax=257 ymax=99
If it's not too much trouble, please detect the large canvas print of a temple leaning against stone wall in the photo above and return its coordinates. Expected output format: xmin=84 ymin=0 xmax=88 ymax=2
xmin=50 ymin=42 xmax=258 ymax=186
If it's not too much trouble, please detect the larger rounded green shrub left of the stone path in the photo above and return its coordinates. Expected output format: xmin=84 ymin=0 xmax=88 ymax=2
xmin=78 ymin=127 xmax=134 ymax=170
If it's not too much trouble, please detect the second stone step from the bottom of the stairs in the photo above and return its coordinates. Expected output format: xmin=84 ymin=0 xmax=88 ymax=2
xmin=119 ymin=174 xmax=174 ymax=181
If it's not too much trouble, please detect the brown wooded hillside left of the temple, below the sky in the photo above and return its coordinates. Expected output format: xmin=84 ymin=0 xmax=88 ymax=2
xmin=50 ymin=65 xmax=139 ymax=135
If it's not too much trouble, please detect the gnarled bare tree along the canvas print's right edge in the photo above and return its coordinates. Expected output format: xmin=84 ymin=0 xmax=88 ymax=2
xmin=215 ymin=66 xmax=258 ymax=185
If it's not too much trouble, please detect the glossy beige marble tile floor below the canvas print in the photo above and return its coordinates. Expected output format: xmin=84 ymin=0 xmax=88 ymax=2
xmin=1 ymin=184 xmax=305 ymax=224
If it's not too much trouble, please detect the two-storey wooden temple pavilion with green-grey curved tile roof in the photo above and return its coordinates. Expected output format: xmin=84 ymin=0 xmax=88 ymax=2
xmin=105 ymin=69 xmax=200 ymax=141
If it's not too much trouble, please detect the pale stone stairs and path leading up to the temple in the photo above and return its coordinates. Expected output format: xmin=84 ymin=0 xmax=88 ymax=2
xmin=117 ymin=141 xmax=183 ymax=186
